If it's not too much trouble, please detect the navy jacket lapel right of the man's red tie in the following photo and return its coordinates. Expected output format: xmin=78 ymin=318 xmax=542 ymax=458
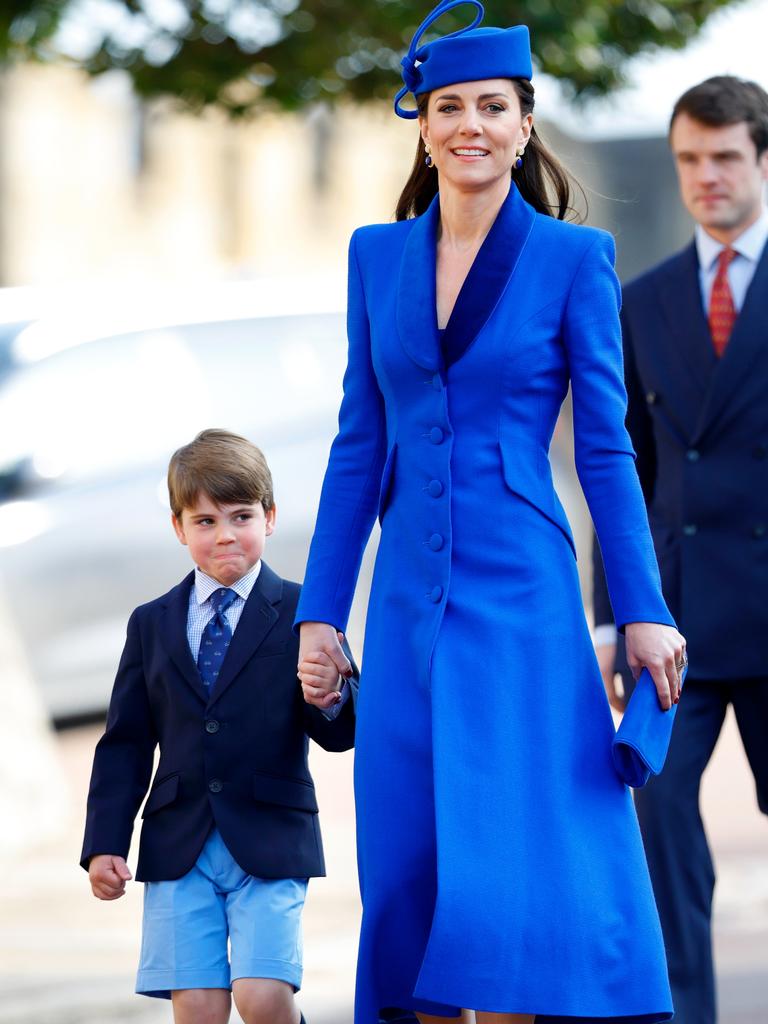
xmin=697 ymin=241 xmax=768 ymax=446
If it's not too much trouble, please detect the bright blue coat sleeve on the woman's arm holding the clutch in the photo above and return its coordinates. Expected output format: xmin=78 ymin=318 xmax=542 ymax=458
xmin=564 ymin=232 xmax=675 ymax=628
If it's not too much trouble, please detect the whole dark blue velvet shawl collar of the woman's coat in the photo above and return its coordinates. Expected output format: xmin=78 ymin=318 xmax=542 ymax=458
xmin=397 ymin=182 xmax=536 ymax=372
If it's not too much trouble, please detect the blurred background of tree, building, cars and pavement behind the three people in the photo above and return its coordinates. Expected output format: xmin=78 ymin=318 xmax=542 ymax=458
xmin=0 ymin=0 xmax=768 ymax=1024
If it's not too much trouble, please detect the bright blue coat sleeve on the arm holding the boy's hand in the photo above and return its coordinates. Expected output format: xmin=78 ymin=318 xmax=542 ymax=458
xmin=296 ymin=234 xmax=386 ymax=631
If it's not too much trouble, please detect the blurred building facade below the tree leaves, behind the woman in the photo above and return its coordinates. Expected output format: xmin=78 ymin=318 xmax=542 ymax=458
xmin=0 ymin=66 xmax=689 ymax=285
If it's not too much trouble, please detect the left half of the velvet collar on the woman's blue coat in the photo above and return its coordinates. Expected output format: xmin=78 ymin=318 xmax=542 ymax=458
xmin=397 ymin=193 xmax=442 ymax=373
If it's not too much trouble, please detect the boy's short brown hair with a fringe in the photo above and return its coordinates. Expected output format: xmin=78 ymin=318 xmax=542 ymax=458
xmin=168 ymin=430 xmax=274 ymax=519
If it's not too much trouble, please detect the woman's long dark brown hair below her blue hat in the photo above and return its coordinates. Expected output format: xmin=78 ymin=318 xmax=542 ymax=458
xmin=395 ymin=78 xmax=586 ymax=220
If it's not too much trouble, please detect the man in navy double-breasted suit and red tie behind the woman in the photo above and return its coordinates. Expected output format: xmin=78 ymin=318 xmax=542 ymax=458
xmin=595 ymin=76 xmax=768 ymax=1024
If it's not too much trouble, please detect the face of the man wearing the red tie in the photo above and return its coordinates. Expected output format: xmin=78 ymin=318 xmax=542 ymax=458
xmin=670 ymin=114 xmax=768 ymax=242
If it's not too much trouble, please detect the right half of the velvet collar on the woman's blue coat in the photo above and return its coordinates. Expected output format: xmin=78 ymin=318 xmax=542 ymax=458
xmin=443 ymin=183 xmax=536 ymax=366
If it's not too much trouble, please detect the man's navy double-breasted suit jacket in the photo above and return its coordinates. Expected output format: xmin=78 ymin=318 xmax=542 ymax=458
xmin=595 ymin=245 xmax=768 ymax=679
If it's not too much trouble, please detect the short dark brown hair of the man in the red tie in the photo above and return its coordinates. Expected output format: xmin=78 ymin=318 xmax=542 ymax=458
xmin=670 ymin=75 xmax=768 ymax=157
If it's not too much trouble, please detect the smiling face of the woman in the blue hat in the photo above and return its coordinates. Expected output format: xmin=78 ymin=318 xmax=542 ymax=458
xmin=419 ymin=78 xmax=534 ymax=190
